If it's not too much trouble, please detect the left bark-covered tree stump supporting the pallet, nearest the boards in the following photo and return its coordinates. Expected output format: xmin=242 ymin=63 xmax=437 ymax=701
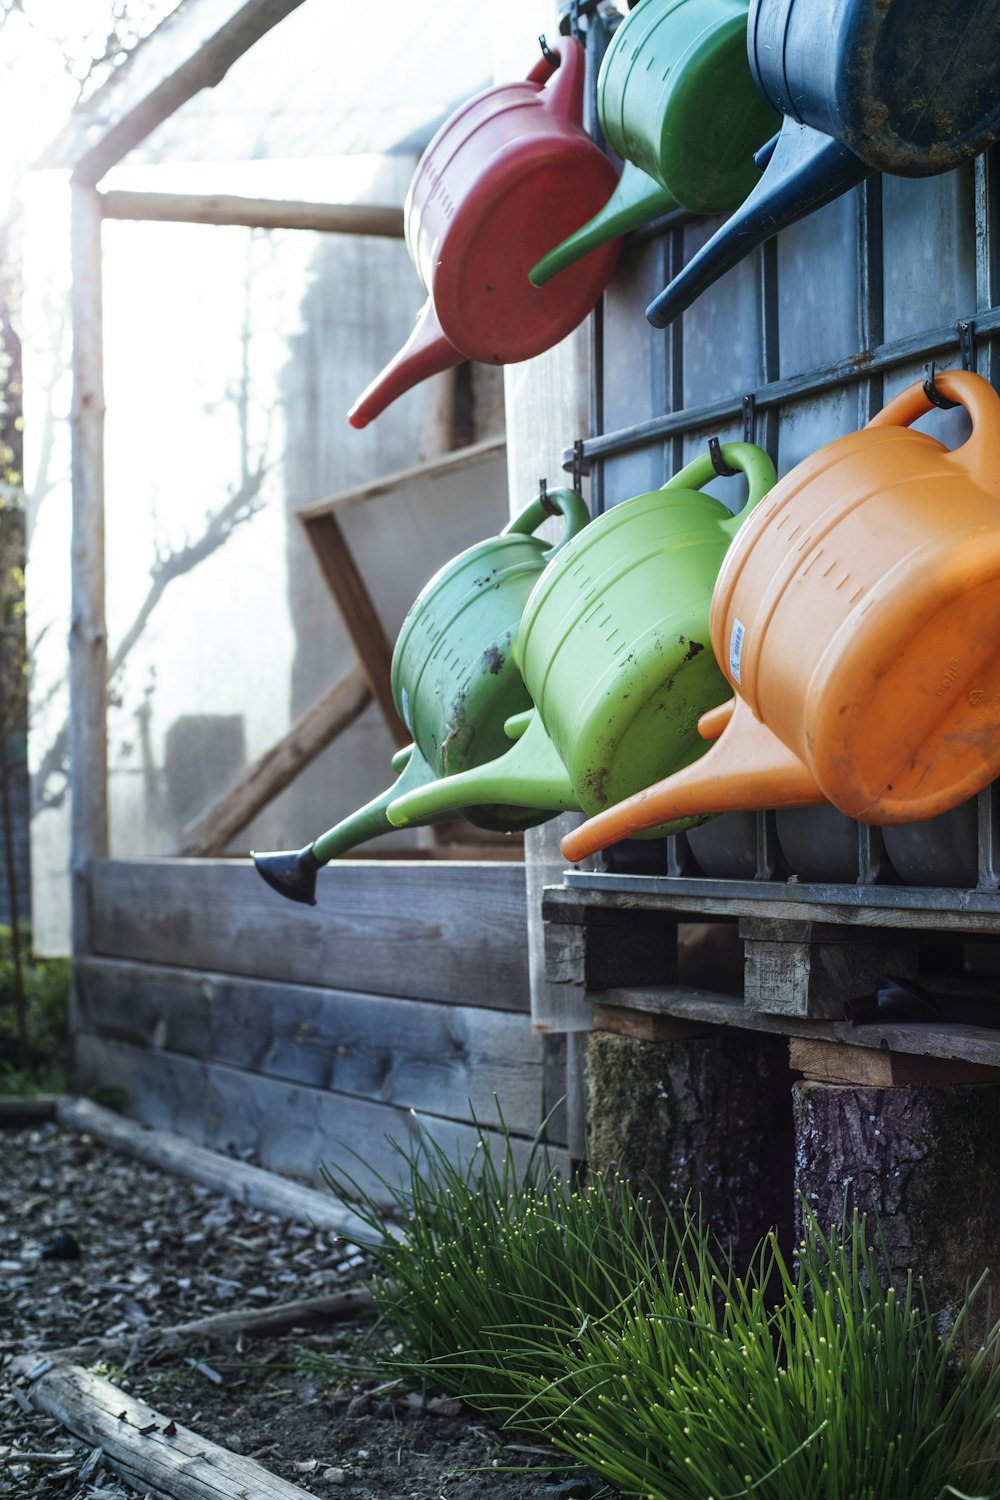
xmin=588 ymin=1029 xmax=793 ymax=1257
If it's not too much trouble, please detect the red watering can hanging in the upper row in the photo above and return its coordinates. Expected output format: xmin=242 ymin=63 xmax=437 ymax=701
xmin=348 ymin=38 xmax=621 ymax=428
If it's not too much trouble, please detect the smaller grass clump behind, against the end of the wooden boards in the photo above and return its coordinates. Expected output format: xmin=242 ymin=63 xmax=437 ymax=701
xmin=322 ymin=1125 xmax=655 ymax=1419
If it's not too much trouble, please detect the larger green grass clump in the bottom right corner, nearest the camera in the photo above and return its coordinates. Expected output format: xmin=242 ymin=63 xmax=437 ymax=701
xmin=517 ymin=1218 xmax=1000 ymax=1500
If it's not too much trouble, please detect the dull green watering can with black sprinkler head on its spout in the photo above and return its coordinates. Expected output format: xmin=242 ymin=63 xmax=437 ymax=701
xmin=252 ymin=489 xmax=590 ymax=906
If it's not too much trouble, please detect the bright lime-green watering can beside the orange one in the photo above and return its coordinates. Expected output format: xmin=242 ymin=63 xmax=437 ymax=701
xmin=388 ymin=443 xmax=775 ymax=839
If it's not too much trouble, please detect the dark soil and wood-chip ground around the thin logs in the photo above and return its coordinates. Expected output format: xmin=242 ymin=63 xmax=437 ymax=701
xmin=0 ymin=1125 xmax=609 ymax=1500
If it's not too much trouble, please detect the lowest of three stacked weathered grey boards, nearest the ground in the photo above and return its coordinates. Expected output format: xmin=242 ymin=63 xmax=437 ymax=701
xmin=76 ymin=1032 xmax=562 ymax=1197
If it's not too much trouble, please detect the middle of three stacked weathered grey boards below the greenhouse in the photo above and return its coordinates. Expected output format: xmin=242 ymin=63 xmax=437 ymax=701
xmin=76 ymin=959 xmax=546 ymax=1136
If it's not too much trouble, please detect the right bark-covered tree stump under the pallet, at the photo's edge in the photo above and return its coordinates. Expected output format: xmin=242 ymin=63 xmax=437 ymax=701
xmin=793 ymin=1082 xmax=1000 ymax=1319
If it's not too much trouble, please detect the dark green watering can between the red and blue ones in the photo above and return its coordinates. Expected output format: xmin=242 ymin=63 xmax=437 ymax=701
xmin=529 ymin=0 xmax=780 ymax=287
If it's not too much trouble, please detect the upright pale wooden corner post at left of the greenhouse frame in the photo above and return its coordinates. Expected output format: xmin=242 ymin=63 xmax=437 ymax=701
xmin=69 ymin=183 xmax=108 ymax=957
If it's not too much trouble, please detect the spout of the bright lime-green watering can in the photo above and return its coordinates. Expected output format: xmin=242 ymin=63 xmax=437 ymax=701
xmin=388 ymin=711 xmax=580 ymax=828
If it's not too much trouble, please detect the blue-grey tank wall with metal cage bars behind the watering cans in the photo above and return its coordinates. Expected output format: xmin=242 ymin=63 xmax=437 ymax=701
xmin=568 ymin=152 xmax=1000 ymax=927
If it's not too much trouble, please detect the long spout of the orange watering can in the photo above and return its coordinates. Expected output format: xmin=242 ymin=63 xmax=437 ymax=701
xmin=559 ymin=699 xmax=826 ymax=864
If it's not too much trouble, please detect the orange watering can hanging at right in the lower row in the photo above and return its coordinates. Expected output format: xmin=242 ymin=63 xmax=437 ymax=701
xmin=562 ymin=371 xmax=1000 ymax=860
